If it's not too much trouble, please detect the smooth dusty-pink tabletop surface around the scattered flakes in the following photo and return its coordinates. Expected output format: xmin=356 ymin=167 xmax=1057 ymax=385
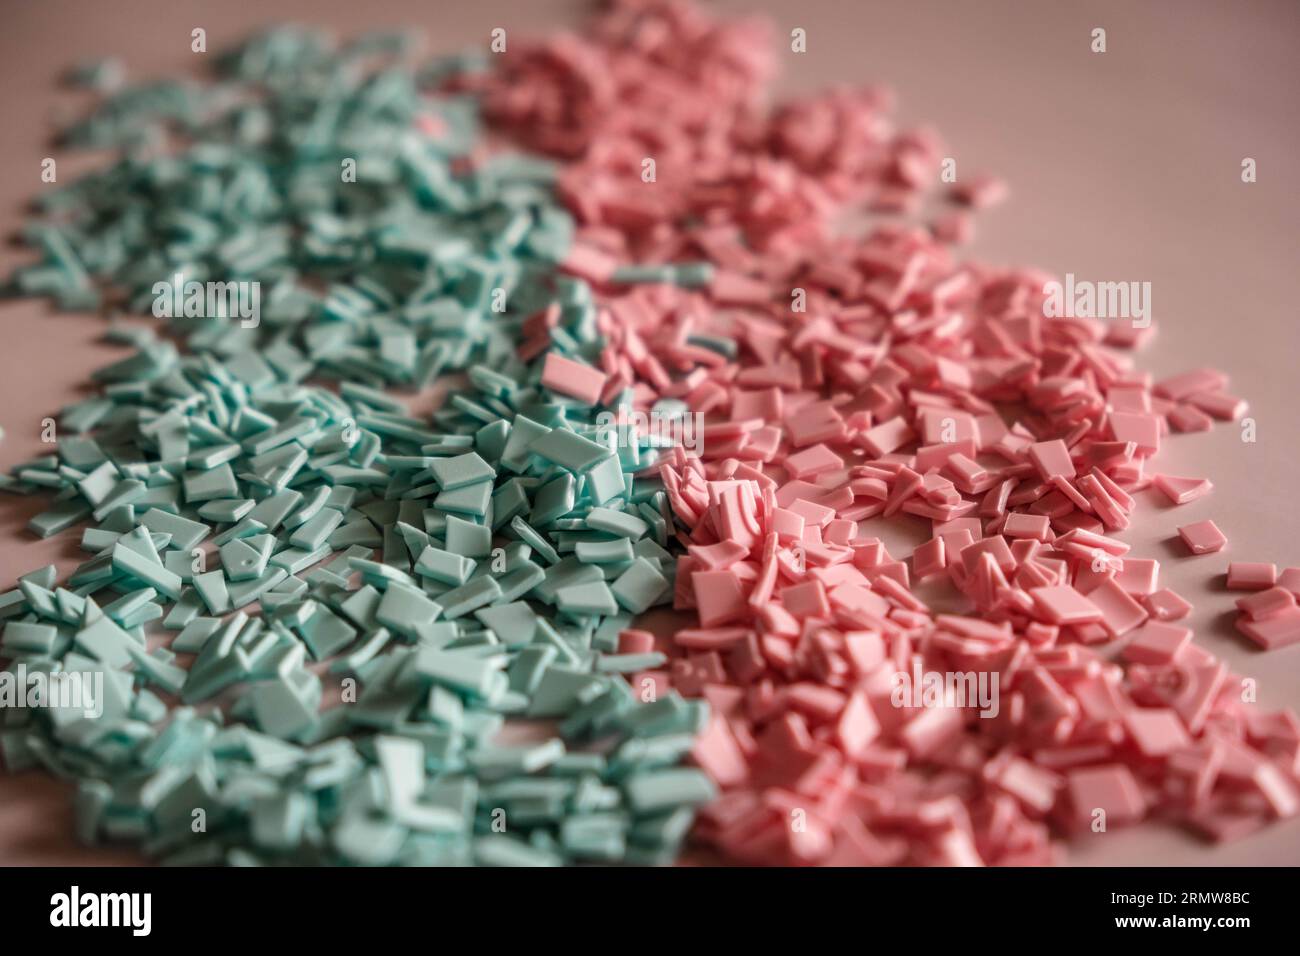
xmin=0 ymin=0 xmax=1300 ymax=865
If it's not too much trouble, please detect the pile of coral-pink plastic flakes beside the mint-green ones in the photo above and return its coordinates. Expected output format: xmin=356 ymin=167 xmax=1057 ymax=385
xmin=473 ymin=1 xmax=1300 ymax=865
